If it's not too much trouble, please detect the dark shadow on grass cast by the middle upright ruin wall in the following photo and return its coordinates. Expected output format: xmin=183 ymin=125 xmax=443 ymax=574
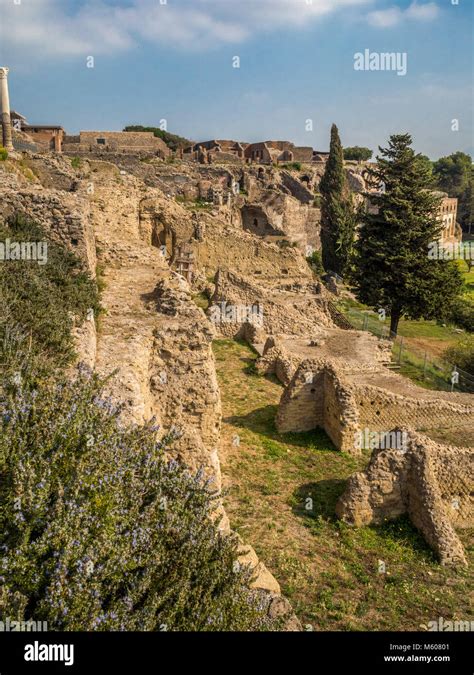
xmin=223 ymin=405 xmax=336 ymax=452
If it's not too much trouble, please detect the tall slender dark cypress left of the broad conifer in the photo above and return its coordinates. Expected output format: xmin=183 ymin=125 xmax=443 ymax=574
xmin=319 ymin=124 xmax=356 ymax=275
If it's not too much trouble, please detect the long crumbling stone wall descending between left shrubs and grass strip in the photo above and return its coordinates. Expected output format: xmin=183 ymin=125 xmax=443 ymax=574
xmin=0 ymin=153 xmax=303 ymax=630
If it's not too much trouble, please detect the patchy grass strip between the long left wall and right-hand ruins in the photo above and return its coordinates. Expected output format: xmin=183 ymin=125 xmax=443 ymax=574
xmin=214 ymin=340 xmax=474 ymax=630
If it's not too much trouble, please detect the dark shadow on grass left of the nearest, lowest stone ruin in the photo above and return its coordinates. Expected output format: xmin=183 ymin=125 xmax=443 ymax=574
xmin=292 ymin=478 xmax=347 ymax=522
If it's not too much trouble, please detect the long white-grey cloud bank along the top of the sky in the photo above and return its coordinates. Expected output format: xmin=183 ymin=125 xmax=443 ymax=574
xmin=0 ymin=0 xmax=374 ymax=58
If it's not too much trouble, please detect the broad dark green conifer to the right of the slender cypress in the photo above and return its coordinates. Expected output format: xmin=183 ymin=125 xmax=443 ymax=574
xmin=353 ymin=134 xmax=463 ymax=335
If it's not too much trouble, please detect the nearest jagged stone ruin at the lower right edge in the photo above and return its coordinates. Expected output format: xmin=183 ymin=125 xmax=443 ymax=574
xmin=336 ymin=430 xmax=474 ymax=565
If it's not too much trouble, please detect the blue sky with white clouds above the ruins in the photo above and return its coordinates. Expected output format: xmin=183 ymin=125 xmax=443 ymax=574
xmin=0 ymin=0 xmax=474 ymax=158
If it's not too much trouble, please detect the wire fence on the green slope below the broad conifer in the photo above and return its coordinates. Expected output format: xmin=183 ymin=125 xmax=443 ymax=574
xmin=338 ymin=305 xmax=474 ymax=394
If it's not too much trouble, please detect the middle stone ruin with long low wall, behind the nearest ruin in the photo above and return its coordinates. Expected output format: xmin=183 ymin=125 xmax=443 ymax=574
xmin=274 ymin=356 xmax=474 ymax=455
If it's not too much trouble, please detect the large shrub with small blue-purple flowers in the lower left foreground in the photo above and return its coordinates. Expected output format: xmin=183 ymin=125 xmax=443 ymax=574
xmin=0 ymin=373 xmax=273 ymax=631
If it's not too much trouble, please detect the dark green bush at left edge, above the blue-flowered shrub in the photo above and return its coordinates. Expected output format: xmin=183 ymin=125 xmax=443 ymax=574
xmin=0 ymin=218 xmax=100 ymax=382
